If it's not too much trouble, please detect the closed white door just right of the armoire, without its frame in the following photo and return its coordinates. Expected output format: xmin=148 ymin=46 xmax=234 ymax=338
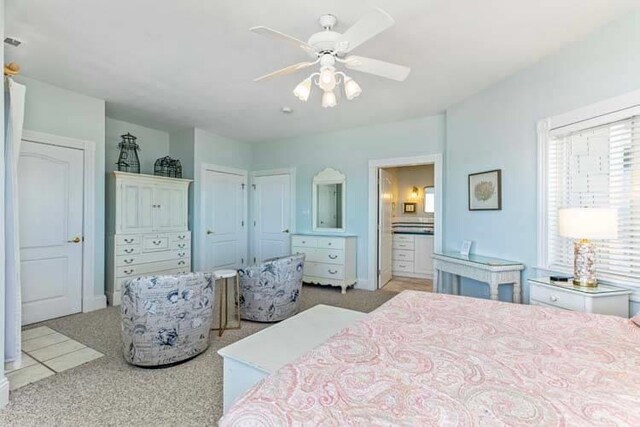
xmin=200 ymin=170 xmax=247 ymax=271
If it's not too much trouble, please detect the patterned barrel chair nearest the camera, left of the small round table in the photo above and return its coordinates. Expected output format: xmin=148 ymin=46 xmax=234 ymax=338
xmin=121 ymin=273 xmax=214 ymax=367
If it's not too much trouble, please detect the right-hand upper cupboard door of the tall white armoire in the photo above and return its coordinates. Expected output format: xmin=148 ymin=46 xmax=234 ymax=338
xmin=153 ymin=185 xmax=188 ymax=231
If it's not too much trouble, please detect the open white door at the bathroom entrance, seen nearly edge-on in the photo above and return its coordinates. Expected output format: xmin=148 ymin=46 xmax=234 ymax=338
xmin=378 ymin=169 xmax=393 ymax=288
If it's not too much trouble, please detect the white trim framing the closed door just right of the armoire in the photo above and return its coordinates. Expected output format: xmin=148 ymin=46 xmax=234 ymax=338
xmin=198 ymin=163 xmax=249 ymax=270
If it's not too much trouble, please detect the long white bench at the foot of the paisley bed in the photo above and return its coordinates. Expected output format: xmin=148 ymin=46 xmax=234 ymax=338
xmin=218 ymin=305 xmax=366 ymax=413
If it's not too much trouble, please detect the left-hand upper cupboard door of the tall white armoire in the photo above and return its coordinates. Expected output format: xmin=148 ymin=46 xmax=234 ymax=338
xmin=119 ymin=181 xmax=154 ymax=233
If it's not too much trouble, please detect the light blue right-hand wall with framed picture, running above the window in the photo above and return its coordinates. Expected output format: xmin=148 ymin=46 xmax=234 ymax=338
xmin=445 ymin=13 xmax=640 ymax=301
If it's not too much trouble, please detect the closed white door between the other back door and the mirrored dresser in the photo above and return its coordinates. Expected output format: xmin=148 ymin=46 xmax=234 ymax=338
xmin=253 ymin=174 xmax=291 ymax=262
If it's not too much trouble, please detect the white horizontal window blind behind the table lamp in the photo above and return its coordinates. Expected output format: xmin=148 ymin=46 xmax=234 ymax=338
xmin=547 ymin=115 xmax=640 ymax=282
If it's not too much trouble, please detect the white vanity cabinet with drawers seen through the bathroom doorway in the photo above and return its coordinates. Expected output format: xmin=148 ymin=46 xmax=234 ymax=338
xmin=392 ymin=234 xmax=433 ymax=279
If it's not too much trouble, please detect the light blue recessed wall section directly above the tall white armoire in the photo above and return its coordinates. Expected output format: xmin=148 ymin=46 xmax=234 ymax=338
xmin=105 ymin=117 xmax=169 ymax=175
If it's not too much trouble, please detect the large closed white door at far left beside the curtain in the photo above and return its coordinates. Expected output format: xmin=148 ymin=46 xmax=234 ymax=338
xmin=18 ymin=141 xmax=84 ymax=324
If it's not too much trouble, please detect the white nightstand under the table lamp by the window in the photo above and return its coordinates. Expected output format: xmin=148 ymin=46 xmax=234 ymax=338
xmin=528 ymin=277 xmax=631 ymax=318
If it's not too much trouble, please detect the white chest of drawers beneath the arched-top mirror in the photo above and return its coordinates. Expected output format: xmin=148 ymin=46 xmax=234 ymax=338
xmin=291 ymin=234 xmax=357 ymax=294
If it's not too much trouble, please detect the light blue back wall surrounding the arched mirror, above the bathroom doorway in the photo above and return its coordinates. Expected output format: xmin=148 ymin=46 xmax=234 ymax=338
xmin=252 ymin=115 xmax=445 ymax=280
